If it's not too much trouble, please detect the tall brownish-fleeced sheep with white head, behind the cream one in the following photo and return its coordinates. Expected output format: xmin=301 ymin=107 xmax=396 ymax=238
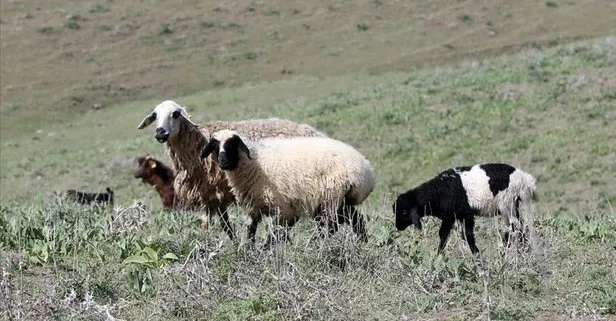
xmin=137 ymin=100 xmax=326 ymax=239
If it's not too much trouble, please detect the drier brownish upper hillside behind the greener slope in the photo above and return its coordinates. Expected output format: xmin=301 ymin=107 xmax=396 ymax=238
xmin=0 ymin=0 xmax=616 ymax=130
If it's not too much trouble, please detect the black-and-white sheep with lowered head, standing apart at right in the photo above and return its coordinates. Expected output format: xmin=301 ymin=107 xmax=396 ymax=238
xmin=392 ymin=163 xmax=539 ymax=254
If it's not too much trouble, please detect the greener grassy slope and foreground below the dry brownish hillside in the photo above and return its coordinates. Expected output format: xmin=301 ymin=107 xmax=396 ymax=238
xmin=0 ymin=36 xmax=616 ymax=320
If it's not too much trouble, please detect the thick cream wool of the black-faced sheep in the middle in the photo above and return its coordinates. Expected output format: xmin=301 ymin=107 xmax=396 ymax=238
xmin=212 ymin=131 xmax=376 ymax=221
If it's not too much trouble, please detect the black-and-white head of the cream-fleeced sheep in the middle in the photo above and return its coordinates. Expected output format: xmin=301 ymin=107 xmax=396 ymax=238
xmin=200 ymin=129 xmax=250 ymax=171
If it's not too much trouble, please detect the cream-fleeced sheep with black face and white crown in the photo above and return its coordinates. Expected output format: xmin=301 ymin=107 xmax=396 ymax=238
xmin=200 ymin=129 xmax=376 ymax=247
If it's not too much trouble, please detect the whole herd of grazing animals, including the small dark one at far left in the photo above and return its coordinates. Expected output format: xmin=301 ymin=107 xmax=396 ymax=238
xmin=67 ymin=100 xmax=538 ymax=254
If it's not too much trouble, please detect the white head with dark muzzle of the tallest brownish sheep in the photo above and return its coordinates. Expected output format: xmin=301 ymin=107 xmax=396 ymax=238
xmin=137 ymin=100 xmax=196 ymax=144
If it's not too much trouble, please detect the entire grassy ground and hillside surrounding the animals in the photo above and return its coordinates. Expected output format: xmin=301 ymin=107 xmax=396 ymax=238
xmin=0 ymin=0 xmax=616 ymax=320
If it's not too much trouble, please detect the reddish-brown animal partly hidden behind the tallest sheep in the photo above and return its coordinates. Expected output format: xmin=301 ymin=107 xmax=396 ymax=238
xmin=135 ymin=156 xmax=175 ymax=210
